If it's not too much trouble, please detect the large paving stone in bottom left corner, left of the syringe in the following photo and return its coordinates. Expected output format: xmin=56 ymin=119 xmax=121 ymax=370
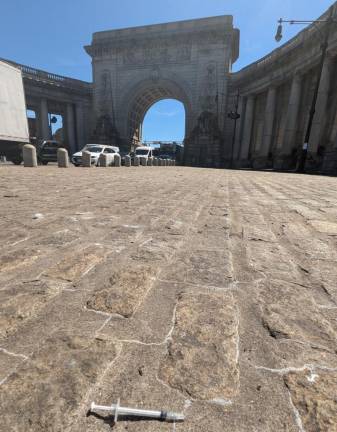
xmin=0 ymin=333 xmax=116 ymax=432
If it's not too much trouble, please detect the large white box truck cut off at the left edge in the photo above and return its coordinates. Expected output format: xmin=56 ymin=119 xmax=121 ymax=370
xmin=0 ymin=61 xmax=29 ymax=165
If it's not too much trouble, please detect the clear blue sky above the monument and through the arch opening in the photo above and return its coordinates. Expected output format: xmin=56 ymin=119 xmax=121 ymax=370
xmin=0 ymin=0 xmax=332 ymax=139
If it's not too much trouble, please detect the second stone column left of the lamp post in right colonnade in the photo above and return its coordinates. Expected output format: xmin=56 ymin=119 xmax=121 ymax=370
xmin=253 ymin=87 xmax=276 ymax=168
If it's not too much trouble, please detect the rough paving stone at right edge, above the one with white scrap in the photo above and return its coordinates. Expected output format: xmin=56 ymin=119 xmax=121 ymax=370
xmin=258 ymin=281 xmax=337 ymax=366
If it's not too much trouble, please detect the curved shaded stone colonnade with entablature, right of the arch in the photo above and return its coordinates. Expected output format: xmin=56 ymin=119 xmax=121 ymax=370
xmin=228 ymin=2 xmax=337 ymax=173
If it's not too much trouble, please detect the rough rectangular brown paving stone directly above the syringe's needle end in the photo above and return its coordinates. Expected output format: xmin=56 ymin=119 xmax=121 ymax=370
xmin=160 ymin=293 xmax=239 ymax=400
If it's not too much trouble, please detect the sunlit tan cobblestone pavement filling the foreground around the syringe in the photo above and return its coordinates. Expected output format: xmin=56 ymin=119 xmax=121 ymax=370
xmin=0 ymin=166 xmax=337 ymax=432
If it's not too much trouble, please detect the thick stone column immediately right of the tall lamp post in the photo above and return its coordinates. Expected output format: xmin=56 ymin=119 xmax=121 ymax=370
xmin=307 ymin=56 xmax=333 ymax=160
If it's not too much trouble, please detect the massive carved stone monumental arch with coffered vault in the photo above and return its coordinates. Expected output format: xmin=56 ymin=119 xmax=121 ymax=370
xmin=85 ymin=16 xmax=239 ymax=166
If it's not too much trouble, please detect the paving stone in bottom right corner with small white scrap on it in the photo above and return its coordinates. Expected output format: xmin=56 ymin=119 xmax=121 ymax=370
xmin=284 ymin=369 xmax=337 ymax=432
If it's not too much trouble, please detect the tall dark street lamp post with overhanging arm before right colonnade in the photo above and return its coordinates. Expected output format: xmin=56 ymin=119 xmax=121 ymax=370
xmin=275 ymin=6 xmax=337 ymax=172
